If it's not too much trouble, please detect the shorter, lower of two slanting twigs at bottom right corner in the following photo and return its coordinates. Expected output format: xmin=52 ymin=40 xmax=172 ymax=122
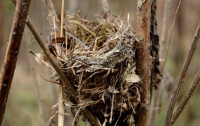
xmin=171 ymin=69 xmax=200 ymax=124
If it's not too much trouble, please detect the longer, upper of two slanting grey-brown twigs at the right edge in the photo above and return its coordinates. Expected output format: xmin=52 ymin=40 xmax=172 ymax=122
xmin=165 ymin=23 xmax=200 ymax=126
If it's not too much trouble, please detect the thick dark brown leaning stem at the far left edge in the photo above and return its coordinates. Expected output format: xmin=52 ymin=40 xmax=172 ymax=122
xmin=0 ymin=0 xmax=30 ymax=125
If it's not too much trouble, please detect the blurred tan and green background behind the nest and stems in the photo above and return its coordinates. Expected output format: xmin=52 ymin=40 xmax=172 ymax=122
xmin=0 ymin=0 xmax=200 ymax=126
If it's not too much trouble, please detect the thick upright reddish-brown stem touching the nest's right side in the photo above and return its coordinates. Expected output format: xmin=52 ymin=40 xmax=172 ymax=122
xmin=136 ymin=0 xmax=152 ymax=126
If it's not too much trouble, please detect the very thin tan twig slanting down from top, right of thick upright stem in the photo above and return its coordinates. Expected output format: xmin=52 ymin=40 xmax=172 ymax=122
xmin=161 ymin=0 xmax=182 ymax=73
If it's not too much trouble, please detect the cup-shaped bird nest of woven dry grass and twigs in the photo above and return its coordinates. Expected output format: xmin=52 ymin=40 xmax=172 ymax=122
xmin=50 ymin=14 xmax=140 ymax=123
